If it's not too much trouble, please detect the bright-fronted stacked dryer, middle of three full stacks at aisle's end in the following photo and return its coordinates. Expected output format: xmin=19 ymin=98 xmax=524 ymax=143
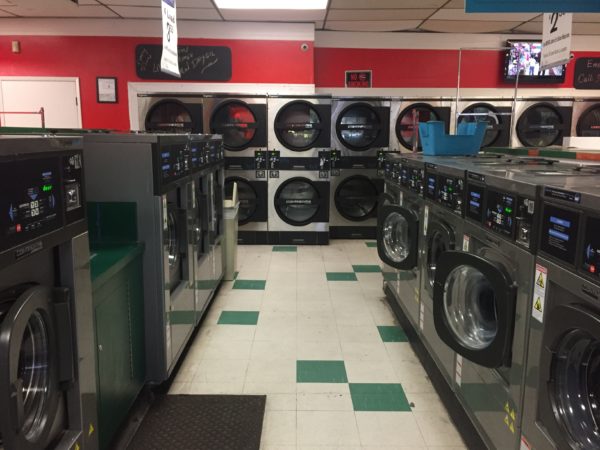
xmin=268 ymin=96 xmax=331 ymax=244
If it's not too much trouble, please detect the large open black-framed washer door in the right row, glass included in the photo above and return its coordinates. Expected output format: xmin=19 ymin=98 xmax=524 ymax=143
xmin=433 ymin=251 xmax=516 ymax=368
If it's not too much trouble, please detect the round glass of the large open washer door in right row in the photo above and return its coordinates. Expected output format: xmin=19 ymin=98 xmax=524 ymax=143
xmin=444 ymin=266 xmax=498 ymax=350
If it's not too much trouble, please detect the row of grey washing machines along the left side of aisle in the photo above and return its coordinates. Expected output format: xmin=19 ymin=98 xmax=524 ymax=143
xmin=0 ymin=133 xmax=224 ymax=450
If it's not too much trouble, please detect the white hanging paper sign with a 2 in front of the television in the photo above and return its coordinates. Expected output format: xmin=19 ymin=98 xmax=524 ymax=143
xmin=540 ymin=13 xmax=573 ymax=70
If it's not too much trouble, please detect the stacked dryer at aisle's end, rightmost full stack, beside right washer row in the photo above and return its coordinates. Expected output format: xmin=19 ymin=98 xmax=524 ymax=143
xmin=330 ymin=97 xmax=391 ymax=239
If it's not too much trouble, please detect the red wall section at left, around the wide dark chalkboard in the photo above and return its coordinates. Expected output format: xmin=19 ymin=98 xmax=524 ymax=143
xmin=0 ymin=36 xmax=314 ymax=130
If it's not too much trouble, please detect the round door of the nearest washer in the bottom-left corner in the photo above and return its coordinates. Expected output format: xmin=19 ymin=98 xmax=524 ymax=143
xmin=0 ymin=285 xmax=65 ymax=449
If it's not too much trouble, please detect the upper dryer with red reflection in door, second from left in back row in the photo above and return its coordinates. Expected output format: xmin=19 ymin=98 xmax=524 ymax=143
xmin=204 ymin=94 xmax=267 ymax=157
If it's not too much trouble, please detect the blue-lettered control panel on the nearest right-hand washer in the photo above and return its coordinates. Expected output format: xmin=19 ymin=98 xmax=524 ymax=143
xmin=540 ymin=204 xmax=579 ymax=264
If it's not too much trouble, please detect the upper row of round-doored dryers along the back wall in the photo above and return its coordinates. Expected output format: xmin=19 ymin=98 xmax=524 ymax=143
xmin=138 ymin=94 xmax=600 ymax=153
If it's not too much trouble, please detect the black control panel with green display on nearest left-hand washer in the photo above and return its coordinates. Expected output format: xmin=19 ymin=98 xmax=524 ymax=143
xmin=0 ymin=151 xmax=85 ymax=256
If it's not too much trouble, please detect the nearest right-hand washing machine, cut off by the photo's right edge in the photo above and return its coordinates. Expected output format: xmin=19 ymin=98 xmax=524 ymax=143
xmin=521 ymin=178 xmax=600 ymax=449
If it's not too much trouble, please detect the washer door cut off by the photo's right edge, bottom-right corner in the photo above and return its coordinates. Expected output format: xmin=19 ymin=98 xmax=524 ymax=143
xmin=538 ymin=304 xmax=600 ymax=449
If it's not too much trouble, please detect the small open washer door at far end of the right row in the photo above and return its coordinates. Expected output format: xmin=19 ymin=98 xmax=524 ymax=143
xmin=377 ymin=203 xmax=419 ymax=270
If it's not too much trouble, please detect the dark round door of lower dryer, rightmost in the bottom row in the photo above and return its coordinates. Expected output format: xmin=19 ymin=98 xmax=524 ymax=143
xmin=334 ymin=175 xmax=378 ymax=221
